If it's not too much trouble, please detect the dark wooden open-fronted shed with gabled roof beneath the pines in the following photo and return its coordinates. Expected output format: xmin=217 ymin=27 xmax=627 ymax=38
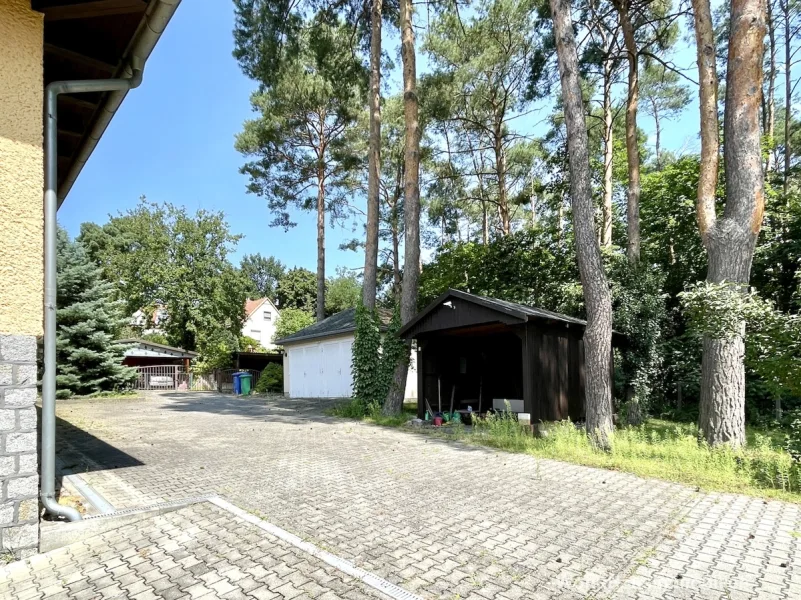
xmin=400 ymin=290 xmax=612 ymax=423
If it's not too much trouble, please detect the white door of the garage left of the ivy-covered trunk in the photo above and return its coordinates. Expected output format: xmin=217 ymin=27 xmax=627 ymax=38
xmin=287 ymin=338 xmax=353 ymax=398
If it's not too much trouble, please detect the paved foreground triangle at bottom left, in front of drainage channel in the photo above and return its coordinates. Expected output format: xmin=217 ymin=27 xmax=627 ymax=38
xmin=0 ymin=502 xmax=383 ymax=600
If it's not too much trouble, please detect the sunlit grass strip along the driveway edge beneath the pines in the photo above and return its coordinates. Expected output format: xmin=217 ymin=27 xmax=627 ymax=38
xmin=331 ymin=403 xmax=801 ymax=504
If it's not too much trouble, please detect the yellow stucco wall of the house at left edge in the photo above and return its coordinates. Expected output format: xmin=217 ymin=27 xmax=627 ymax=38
xmin=0 ymin=0 xmax=43 ymax=335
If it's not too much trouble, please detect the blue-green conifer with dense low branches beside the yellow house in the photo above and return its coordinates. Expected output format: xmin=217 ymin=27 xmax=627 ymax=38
xmin=56 ymin=229 xmax=136 ymax=398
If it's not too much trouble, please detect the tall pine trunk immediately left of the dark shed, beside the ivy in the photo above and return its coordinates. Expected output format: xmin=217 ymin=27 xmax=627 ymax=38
xmin=384 ymin=0 xmax=420 ymax=415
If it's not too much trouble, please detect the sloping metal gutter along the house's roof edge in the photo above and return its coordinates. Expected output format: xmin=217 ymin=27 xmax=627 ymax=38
xmin=58 ymin=0 xmax=181 ymax=207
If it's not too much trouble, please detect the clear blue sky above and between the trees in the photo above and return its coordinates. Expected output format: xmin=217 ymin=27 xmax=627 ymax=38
xmin=59 ymin=0 xmax=698 ymax=275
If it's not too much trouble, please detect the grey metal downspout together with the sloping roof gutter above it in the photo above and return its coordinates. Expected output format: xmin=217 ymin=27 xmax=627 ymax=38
xmin=39 ymin=0 xmax=181 ymax=521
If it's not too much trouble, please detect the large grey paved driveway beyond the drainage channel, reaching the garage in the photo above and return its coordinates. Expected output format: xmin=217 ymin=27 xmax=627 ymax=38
xmin=51 ymin=393 xmax=801 ymax=600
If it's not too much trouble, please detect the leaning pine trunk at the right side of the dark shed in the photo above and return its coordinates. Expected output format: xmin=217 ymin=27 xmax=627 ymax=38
xmin=550 ymin=0 xmax=613 ymax=448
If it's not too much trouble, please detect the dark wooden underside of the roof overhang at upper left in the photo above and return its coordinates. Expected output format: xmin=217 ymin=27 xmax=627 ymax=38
xmin=31 ymin=0 xmax=180 ymax=206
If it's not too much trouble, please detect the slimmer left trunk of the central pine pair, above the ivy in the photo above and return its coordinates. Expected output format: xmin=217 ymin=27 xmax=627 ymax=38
xmin=362 ymin=0 xmax=382 ymax=310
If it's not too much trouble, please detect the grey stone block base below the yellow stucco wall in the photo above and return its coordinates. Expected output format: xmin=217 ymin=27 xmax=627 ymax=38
xmin=0 ymin=334 xmax=39 ymax=558
